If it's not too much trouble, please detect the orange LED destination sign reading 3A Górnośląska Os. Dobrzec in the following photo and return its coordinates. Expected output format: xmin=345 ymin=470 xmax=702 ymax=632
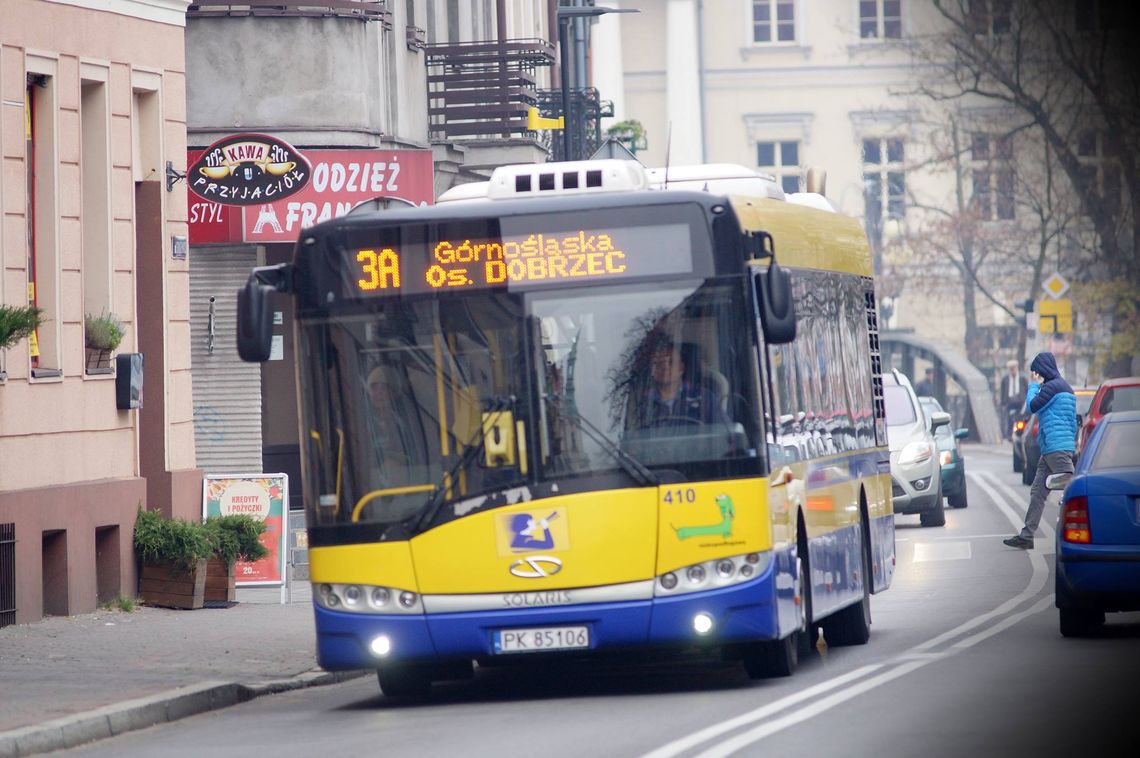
xmin=349 ymin=223 xmax=693 ymax=295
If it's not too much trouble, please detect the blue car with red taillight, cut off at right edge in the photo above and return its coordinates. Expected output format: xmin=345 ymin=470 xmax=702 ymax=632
xmin=1056 ymin=410 xmax=1140 ymax=637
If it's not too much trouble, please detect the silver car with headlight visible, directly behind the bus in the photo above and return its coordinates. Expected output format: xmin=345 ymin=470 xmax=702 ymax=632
xmin=882 ymin=369 xmax=950 ymax=527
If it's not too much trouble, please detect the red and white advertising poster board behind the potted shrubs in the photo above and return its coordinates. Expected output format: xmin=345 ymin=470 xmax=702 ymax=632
xmin=202 ymin=474 xmax=288 ymax=587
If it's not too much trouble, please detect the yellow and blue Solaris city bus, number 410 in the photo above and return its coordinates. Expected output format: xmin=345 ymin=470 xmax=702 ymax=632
xmin=238 ymin=161 xmax=895 ymax=695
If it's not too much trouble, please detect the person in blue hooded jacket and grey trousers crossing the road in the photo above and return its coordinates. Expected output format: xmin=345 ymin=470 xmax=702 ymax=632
xmin=1002 ymin=352 xmax=1076 ymax=549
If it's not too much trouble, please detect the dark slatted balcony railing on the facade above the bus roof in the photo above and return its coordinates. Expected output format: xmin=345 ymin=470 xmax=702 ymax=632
xmin=425 ymin=39 xmax=554 ymax=139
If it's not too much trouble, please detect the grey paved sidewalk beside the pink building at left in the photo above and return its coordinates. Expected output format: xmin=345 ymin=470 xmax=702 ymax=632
xmin=0 ymin=582 xmax=358 ymax=758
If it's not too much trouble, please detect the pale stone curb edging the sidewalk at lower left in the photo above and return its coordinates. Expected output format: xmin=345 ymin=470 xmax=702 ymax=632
xmin=0 ymin=669 xmax=369 ymax=758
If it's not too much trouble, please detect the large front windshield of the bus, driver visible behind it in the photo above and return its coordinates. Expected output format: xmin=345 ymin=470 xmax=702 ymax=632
xmin=300 ymin=276 xmax=759 ymax=538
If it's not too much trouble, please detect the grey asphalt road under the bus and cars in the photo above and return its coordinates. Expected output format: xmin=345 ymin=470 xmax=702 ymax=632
xmin=70 ymin=447 xmax=1140 ymax=758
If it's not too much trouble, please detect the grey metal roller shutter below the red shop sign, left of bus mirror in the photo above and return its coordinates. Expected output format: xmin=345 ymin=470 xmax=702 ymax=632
xmin=190 ymin=245 xmax=262 ymax=474
